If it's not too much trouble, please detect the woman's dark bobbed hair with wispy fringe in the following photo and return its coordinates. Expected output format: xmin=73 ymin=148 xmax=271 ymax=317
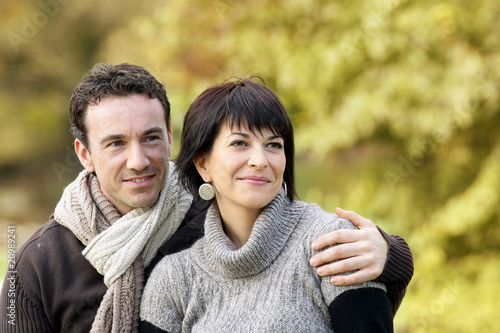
xmin=176 ymin=76 xmax=296 ymax=200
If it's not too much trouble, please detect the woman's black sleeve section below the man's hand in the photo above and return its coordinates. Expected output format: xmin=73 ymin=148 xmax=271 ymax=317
xmin=328 ymin=288 xmax=394 ymax=333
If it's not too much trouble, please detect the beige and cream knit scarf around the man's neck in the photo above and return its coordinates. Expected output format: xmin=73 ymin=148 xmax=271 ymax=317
xmin=54 ymin=163 xmax=192 ymax=332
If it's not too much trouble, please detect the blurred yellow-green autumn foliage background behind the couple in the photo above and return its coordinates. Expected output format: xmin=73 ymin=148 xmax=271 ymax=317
xmin=0 ymin=0 xmax=500 ymax=332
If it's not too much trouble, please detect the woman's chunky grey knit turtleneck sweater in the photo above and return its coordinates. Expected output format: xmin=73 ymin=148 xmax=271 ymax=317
xmin=141 ymin=192 xmax=392 ymax=333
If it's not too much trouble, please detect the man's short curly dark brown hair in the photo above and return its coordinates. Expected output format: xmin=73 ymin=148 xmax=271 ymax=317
xmin=69 ymin=63 xmax=170 ymax=148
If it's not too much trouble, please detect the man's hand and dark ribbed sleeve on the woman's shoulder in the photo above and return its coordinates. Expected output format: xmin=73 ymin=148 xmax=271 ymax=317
xmin=311 ymin=208 xmax=414 ymax=314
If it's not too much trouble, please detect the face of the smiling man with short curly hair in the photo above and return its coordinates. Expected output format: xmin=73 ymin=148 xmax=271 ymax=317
xmin=75 ymin=94 xmax=172 ymax=215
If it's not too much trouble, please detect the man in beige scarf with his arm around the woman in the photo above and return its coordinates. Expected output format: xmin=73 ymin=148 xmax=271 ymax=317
xmin=0 ymin=64 xmax=413 ymax=332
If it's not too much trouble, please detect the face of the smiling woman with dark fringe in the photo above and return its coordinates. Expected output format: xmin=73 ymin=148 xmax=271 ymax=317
xmin=195 ymin=124 xmax=286 ymax=218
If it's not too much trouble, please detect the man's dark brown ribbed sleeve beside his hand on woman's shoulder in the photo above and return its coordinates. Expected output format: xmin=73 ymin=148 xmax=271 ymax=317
xmin=375 ymin=228 xmax=414 ymax=316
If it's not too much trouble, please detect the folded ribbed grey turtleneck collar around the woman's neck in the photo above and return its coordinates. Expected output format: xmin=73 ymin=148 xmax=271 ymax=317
xmin=197 ymin=189 xmax=306 ymax=278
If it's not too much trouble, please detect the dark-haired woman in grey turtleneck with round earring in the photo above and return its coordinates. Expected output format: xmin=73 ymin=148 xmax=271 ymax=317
xmin=141 ymin=78 xmax=393 ymax=332
